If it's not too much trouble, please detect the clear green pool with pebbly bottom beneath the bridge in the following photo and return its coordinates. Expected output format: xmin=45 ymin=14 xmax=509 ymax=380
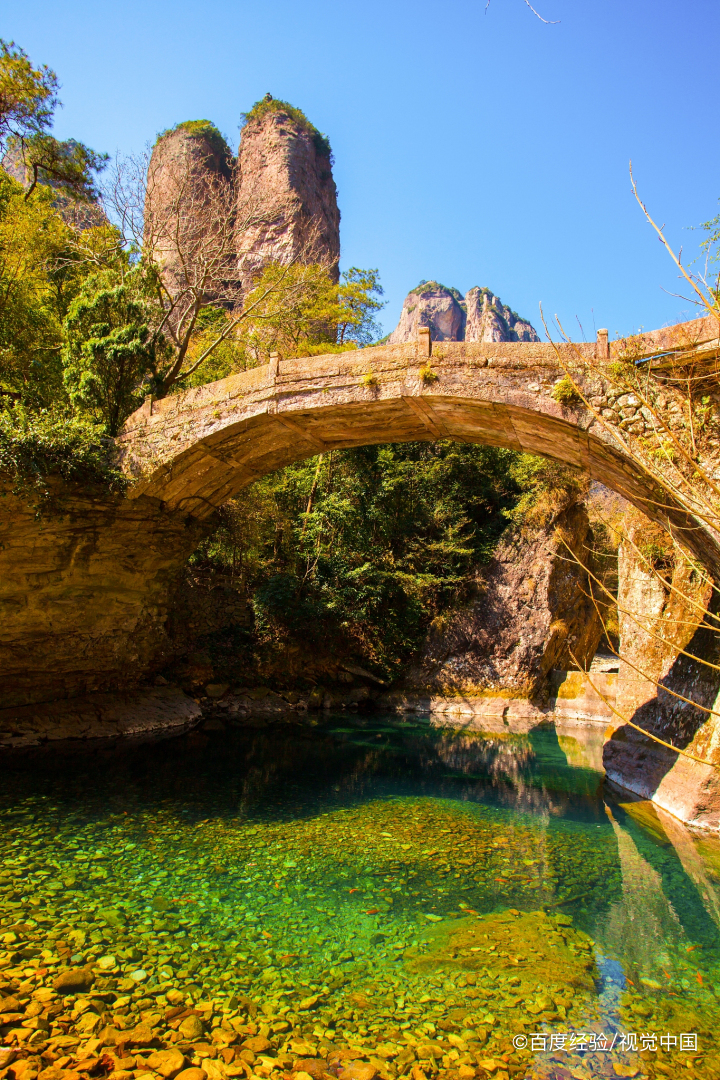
xmin=0 ymin=714 xmax=720 ymax=1080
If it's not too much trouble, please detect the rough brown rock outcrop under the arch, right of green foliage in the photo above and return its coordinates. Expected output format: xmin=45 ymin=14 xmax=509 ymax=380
xmin=399 ymin=503 xmax=602 ymax=696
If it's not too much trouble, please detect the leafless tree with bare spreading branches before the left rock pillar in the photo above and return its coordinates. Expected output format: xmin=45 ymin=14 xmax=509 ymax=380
xmin=106 ymin=143 xmax=325 ymax=397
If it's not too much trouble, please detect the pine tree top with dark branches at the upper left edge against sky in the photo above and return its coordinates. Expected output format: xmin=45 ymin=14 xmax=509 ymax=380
xmin=0 ymin=39 xmax=107 ymax=201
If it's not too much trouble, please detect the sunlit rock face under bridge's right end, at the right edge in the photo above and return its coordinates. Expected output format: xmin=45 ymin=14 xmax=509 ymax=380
xmin=603 ymin=511 xmax=720 ymax=829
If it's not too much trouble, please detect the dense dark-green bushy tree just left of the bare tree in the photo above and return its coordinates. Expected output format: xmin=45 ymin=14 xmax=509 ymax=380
xmin=63 ymin=269 xmax=164 ymax=435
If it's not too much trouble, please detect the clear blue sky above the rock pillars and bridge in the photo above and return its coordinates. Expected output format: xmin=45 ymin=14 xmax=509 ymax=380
xmin=7 ymin=0 xmax=720 ymax=337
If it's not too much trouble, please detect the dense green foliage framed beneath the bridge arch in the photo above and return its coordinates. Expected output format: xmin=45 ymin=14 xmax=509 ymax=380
xmin=195 ymin=443 xmax=520 ymax=675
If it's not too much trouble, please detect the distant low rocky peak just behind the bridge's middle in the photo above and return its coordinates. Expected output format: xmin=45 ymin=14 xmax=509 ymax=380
xmin=388 ymin=281 xmax=540 ymax=345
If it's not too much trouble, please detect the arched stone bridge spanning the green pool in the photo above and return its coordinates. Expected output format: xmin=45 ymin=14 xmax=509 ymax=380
xmin=118 ymin=319 xmax=720 ymax=576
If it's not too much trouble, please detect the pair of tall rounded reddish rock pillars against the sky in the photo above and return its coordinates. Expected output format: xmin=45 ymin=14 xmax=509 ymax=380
xmin=145 ymin=98 xmax=340 ymax=291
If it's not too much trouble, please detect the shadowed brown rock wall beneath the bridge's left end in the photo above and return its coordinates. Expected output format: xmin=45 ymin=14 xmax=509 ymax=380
xmin=0 ymin=482 xmax=204 ymax=708
